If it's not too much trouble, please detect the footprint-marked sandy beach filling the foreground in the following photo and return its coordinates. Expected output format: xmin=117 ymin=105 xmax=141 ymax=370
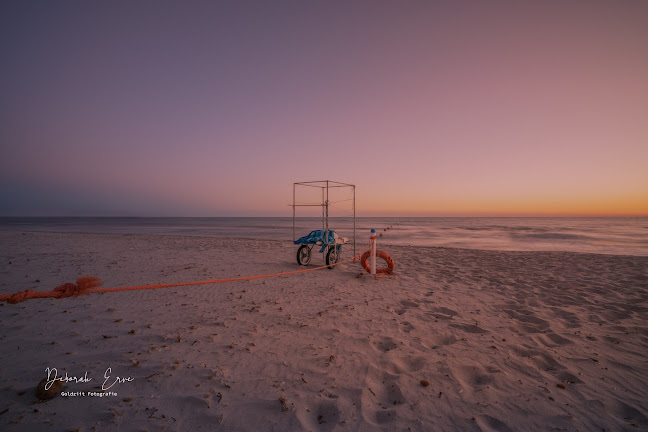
xmin=0 ymin=232 xmax=648 ymax=431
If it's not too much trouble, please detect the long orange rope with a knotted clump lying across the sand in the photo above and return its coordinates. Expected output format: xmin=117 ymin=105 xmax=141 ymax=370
xmin=0 ymin=243 xmax=367 ymax=304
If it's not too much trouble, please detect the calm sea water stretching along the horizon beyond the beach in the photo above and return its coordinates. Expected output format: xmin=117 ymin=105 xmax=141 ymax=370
xmin=0 ymin=217 xmax=648 ymax=256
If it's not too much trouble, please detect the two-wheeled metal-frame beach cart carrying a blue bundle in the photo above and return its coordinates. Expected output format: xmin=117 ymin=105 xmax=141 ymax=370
xmin=292 ymin=180 xmax=356 ymax=269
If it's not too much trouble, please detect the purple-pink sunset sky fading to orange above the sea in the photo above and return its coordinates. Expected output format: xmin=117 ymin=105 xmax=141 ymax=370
xmin=0 ymin=0 xmax=648 ymax=216
